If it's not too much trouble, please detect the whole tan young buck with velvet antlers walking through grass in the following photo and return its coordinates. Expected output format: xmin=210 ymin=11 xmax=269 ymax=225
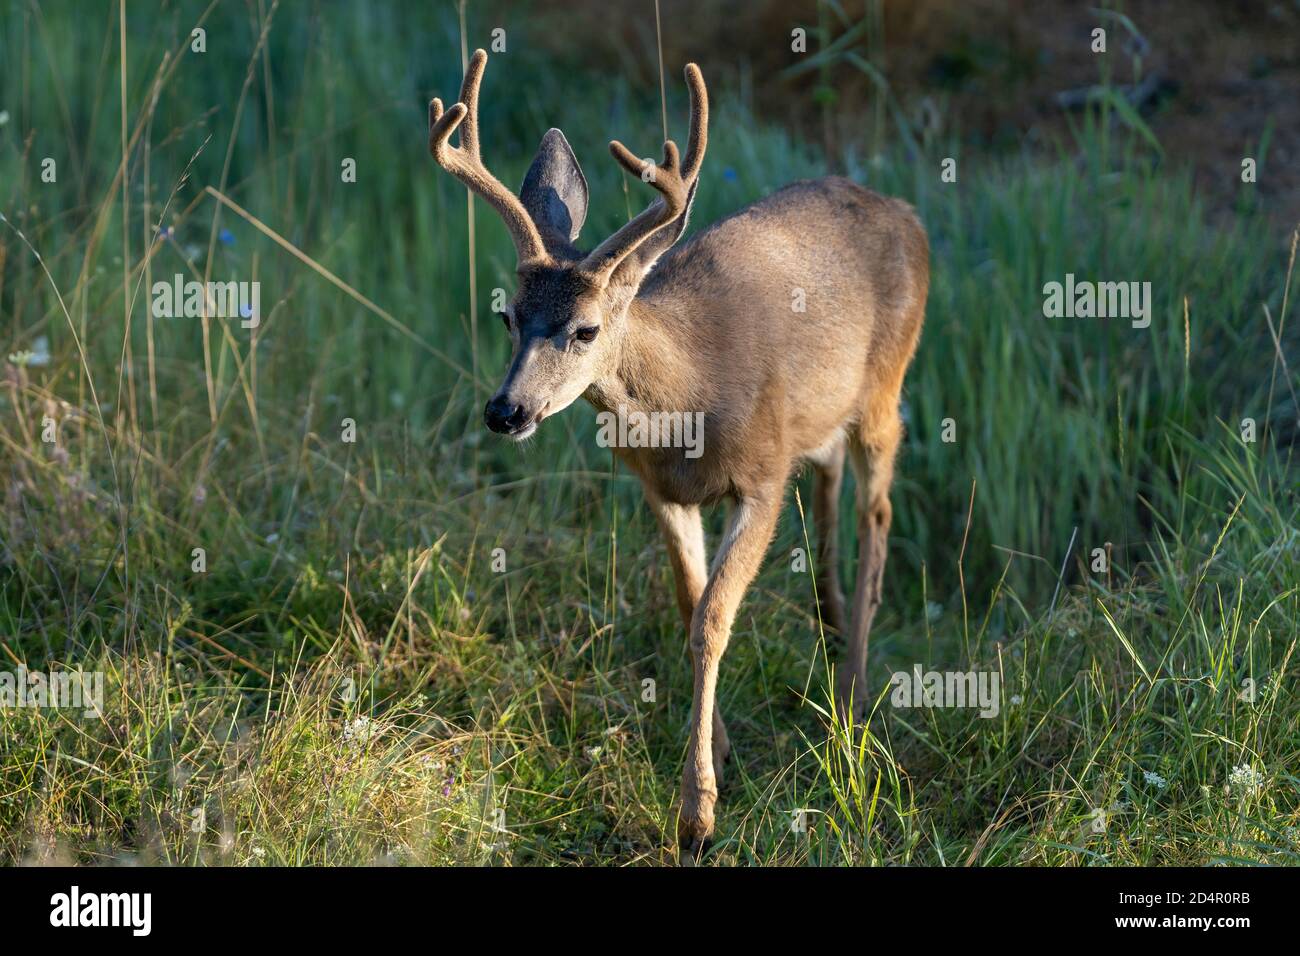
xmin=429 ymin=49 xmax=930 ymax=855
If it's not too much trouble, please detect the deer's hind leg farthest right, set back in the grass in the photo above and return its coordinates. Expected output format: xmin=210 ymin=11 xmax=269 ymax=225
xmin=836 ymin=408 xmax=902 ymax=717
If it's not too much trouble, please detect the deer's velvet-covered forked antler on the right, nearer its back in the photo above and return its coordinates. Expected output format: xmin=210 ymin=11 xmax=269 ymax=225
xmin=579 ymin=64 xmax=709 ymax=281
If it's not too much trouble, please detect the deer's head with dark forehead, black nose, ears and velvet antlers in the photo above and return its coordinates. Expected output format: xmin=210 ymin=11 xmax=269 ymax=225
xmin=429 ymin=49 xmax=709 ymax=440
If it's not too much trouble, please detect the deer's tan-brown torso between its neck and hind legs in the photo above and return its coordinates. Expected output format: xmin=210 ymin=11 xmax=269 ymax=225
xmin=638 ymin=177 xmax=930 ymax=481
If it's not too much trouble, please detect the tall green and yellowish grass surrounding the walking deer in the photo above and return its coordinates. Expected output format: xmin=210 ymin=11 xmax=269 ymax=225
xmin=0 ymin=3 xmax=1300 ymax=865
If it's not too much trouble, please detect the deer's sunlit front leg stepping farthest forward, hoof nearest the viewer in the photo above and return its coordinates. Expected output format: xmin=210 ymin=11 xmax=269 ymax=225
xmin=677 ymin=486 xmax=781 ymax=857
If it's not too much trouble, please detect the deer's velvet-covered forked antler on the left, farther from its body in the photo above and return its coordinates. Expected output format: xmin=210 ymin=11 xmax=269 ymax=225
xmin=429 ymin=49 xmax=547 ymax=265
